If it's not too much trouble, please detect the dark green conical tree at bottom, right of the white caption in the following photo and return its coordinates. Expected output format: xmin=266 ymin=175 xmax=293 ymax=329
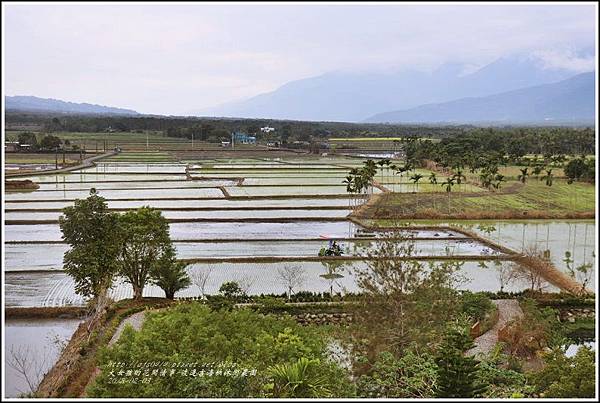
xmin=436 ymin=326 xmax=485 ymax=398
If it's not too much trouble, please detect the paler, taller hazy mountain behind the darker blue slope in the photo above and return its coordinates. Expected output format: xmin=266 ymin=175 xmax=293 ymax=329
xmin=198 ymin=55 xmax=592 ymax=122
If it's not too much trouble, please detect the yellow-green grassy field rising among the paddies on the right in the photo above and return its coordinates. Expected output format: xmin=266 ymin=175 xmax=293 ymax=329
xmin=356 ymin=180 xmax=596 ymax=220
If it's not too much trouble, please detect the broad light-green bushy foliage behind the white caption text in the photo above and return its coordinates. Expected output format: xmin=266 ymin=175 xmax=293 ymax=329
xmin=87 ymin=303 xmax=355 ymax=398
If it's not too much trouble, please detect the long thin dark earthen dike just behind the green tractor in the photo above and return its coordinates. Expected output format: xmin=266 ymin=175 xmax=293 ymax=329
xmin=4 ymin=236 xmax=471 ymax=245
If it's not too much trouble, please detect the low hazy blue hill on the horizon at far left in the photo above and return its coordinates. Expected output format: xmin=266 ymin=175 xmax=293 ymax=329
xmin=4 ymin=95 xmax=138 ymax=115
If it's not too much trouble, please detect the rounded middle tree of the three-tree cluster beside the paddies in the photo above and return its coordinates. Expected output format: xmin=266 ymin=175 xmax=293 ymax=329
xmin=119 ymin=207 xmax=172 ymax=299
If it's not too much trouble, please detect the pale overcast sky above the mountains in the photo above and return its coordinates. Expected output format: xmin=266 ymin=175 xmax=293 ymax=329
xmin=2 ymin=3 xmax=597 ymax=114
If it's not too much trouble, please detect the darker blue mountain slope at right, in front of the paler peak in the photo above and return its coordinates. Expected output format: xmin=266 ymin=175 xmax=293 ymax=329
xmin=365 ymin=73 xmax=596 ymax=124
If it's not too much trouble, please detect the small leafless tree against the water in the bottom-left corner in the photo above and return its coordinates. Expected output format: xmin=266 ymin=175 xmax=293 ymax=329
xmin=6 ymin=344 xmax=48 ymax=394
